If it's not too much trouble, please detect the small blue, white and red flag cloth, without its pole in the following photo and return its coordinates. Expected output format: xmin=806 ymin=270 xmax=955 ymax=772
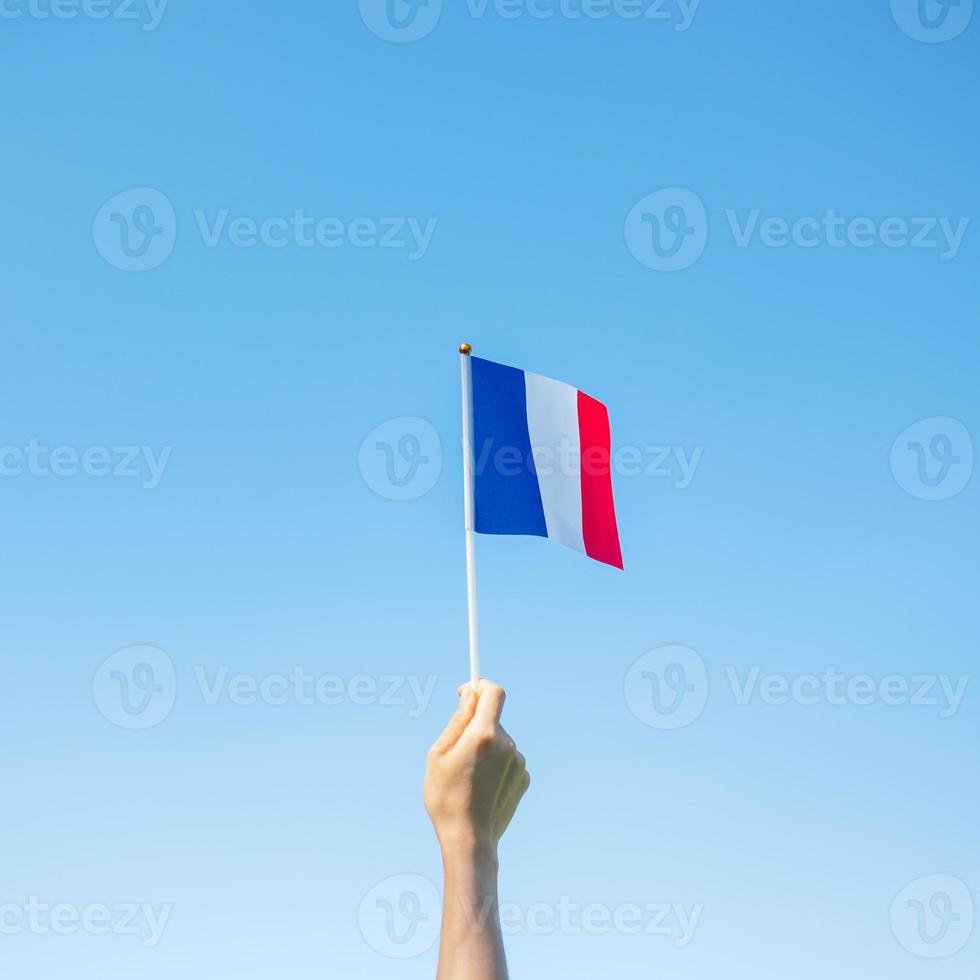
xmin=469 ymin=357 xmax=623 ymax=568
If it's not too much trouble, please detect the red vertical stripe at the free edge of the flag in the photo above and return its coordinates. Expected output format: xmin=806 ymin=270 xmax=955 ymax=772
xmin=578 ymin=391 xmax=623 ymax=568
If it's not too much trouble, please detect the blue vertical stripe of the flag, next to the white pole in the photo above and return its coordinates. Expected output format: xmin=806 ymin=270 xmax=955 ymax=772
xmin=470 ymin=357 xmax=548 ymax=538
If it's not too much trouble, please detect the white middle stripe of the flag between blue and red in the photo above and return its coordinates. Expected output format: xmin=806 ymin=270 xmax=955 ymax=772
xmin=524 ymin=371 xmax=585 ymax=554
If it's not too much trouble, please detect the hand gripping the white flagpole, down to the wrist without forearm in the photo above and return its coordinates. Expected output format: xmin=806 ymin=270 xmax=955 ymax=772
xmin=423 ymin=680 xmax=531 ymax=858
